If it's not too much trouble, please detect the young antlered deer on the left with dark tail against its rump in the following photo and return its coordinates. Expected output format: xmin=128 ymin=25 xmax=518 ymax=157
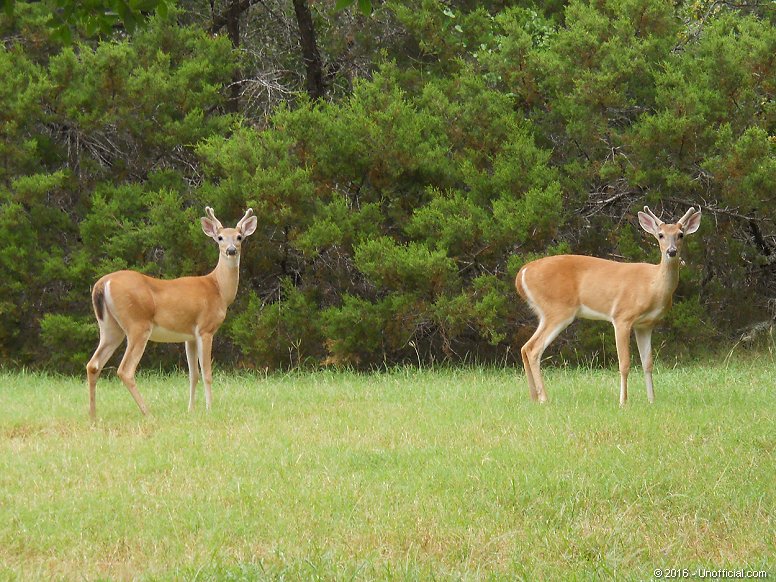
xmin=86 ymin=206 xmax=257 ymax=419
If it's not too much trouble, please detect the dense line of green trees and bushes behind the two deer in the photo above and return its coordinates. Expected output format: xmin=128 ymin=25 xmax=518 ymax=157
xmin=0 ymin=0 xmax=776 ymax=370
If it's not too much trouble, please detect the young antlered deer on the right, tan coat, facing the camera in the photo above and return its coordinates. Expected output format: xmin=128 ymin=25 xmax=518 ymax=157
xmin=515 ymin=206 xmax=701 ymax=407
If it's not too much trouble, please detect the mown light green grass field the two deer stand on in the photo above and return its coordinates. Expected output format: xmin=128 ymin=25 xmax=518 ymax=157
xmin=0 ymin=356 xmax=776 ymax=580
